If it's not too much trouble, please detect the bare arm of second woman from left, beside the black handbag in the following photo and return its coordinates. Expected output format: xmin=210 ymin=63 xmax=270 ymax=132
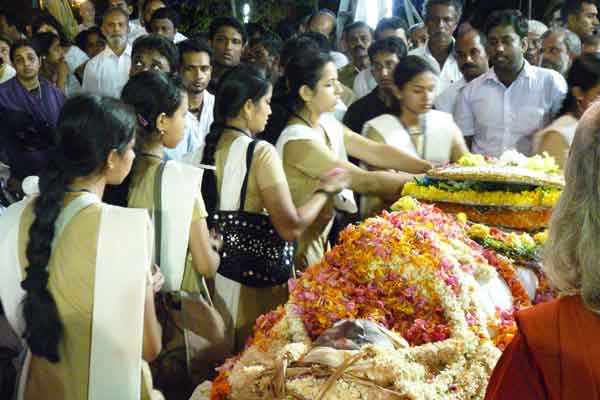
xmin=189 ymin=218 xmax=221 ymax=278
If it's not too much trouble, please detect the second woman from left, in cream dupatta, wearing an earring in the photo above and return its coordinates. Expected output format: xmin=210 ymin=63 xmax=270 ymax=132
xmin=121 ymin=71 xmax=225 ymax=398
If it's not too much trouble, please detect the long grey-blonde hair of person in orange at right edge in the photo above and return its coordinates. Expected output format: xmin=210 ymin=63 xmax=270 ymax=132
xmin=543 ymin=103 xmax=600 ymax=314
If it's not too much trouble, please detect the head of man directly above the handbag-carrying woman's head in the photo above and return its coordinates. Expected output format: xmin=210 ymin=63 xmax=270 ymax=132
xmin=208 ymin=17 xmax=248 ymax=92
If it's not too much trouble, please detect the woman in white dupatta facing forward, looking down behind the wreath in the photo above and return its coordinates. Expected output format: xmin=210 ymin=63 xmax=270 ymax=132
xmin=361 ymin=56 xmax=469 ymax=216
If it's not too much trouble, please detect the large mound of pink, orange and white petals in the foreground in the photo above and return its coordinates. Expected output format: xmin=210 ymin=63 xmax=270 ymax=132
xmin=206 ymin=203 xmax=548 ymax=400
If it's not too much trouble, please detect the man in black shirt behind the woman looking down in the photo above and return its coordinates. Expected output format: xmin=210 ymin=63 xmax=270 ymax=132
xmin=344 ymin=37 xmax=407 ymax=133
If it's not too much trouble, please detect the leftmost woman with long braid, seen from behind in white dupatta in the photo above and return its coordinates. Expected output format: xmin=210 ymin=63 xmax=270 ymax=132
xmin=0 ymin=96 xmax=162 ymax=400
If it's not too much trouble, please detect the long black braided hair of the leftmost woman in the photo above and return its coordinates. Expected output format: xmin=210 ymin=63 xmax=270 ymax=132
xmin=21 ymin=95 xmax=136 ymax=362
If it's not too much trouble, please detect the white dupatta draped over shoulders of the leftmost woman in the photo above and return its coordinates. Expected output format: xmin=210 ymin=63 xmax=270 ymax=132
xmin=0 ymin=194 xmax=151 ymax=400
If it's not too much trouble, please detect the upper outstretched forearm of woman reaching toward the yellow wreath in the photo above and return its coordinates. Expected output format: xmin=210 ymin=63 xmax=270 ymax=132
xmin=344 ymin=128 xmax=433 ymax=174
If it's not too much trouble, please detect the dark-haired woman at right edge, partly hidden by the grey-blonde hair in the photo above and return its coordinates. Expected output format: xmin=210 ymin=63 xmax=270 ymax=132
xmin=533 ymin=53 xmax=600 ymax=168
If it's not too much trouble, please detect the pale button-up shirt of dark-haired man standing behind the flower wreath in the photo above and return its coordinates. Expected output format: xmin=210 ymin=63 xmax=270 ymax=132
xmin=454 ymin=61 xmax=567 ymax=156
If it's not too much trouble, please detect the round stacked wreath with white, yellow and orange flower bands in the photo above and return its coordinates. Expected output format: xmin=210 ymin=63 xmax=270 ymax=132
xmin=403 ymin=151 xmax=564 ymax=231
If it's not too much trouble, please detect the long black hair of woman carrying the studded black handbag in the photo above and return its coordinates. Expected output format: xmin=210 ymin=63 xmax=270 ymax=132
xmin=202 ymin=65 xmax=271 ymax=213
